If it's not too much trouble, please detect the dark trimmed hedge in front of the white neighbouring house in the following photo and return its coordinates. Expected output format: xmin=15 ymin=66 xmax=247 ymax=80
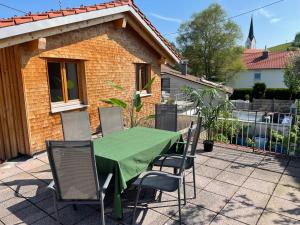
xmin=230 ymin=88 xmax=300 ymax=100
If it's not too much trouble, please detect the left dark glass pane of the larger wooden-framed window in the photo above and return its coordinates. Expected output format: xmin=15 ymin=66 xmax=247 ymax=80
xmin=48 ymin=62 xmax=64 ymax=102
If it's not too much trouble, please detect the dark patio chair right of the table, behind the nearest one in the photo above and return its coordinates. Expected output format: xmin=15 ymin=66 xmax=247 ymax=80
xmin=153 ymin=117 xmax=202 ymax=200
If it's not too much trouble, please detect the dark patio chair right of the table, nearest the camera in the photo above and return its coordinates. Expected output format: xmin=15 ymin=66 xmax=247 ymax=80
xmin=132 ymin=125 xmax=192 ymax=224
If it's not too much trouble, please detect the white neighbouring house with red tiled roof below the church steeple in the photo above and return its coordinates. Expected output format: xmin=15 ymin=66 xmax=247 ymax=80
xmin=228 ymin=49 xmax=296 ymax=89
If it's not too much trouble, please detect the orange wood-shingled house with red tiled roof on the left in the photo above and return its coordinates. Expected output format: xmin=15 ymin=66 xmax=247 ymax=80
xmin=0 ymin=0 xmax=180 ymax=159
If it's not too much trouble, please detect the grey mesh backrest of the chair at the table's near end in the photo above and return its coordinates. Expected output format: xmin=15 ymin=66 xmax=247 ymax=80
xmin=46 ymin=141 xmax=99 ymax=201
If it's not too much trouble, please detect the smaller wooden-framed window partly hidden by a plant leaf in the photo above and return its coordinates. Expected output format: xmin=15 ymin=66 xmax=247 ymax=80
xmin=136 ymin=64 xmax=151 ymax=93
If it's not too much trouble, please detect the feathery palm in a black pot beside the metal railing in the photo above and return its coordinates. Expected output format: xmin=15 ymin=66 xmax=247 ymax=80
xmin=184 ymin=87 xmax=232 ymax=152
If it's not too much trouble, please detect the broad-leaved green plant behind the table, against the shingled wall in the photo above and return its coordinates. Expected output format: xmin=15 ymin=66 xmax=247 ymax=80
xmin=101 ymin=77 xmax=155 ymax=127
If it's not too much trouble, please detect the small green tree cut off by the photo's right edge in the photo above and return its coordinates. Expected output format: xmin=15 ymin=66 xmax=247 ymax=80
xmin=283 ymin=57 xmax=300 ymax=99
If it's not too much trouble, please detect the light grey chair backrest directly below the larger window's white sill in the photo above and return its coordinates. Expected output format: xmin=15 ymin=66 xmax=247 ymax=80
xmin=61 ymin=111 xmax=92 ymax=141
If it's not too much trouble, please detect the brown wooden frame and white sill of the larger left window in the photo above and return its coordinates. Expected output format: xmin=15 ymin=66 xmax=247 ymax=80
xmin=45 ymin=58 xmax=86 ymax=113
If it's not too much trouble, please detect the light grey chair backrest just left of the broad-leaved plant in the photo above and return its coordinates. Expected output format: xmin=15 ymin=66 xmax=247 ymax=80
xmin=99 ymin=107 xmax=124 ymax=136
